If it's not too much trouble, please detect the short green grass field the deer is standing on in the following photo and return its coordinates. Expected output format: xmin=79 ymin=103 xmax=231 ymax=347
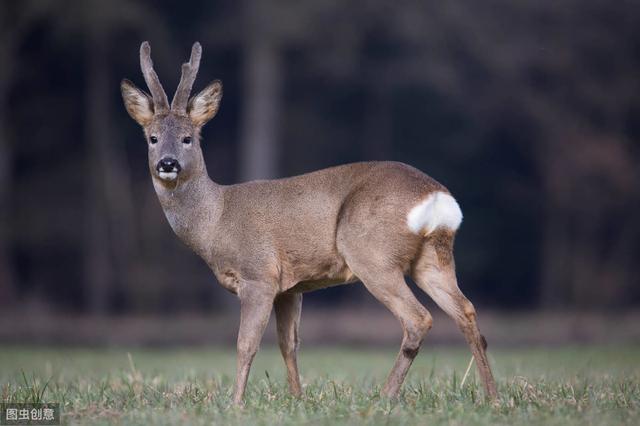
xmin=0 ymin=344 xmax=640 ymax=425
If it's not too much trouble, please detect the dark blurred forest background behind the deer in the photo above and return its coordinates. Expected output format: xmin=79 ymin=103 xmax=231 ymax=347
xmin=0 ymin=0 xmax=640 ymax=315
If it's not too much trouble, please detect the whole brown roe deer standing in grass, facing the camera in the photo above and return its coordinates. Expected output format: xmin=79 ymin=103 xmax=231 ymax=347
xmin=121 ymin=42 xmax=497 ymax=404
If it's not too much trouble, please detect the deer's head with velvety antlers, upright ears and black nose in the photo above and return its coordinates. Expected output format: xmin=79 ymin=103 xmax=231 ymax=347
xmin=120 ymin=41 xmax=222 ymax=188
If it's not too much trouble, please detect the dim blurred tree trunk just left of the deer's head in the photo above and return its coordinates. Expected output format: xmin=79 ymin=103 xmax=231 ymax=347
xmin=85 ymin=14 xmax=136 ymax=315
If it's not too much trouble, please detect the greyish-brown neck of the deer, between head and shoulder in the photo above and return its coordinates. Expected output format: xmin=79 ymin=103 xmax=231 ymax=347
xmin=153 ymin=172 xmax=223 ymax=258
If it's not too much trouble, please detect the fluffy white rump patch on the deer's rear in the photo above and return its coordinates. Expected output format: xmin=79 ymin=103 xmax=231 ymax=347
xmin=407 ymin=191 xmax=462 ymax=235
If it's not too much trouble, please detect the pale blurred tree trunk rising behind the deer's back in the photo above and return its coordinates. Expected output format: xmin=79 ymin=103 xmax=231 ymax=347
xmin=240 ymin=0 xmax=282 ymax=181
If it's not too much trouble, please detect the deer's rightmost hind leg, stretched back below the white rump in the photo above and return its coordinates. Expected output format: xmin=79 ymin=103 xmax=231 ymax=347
xmin=412 ymin=230 xmax=498 ymax=399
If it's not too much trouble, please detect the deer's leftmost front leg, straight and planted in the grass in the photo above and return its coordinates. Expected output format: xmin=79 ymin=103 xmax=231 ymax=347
xmin=233 ymin=286 xmax=275 ymax=405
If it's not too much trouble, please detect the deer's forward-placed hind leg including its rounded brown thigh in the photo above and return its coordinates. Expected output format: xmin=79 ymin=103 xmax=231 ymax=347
xmin=336 ymin=193 xmax=433 ymax=398
